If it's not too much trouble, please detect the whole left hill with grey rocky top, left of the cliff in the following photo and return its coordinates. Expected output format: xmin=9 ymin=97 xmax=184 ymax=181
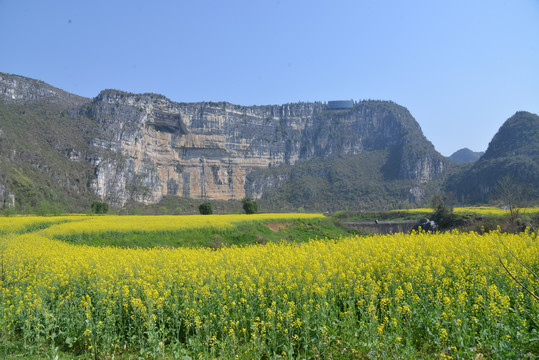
xmin=0 ymin=73 xmax=97 ymax=212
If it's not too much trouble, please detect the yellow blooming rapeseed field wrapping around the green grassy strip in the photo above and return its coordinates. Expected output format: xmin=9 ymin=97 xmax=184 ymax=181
xmin=0 ymin=214 xmax=539 ymax=359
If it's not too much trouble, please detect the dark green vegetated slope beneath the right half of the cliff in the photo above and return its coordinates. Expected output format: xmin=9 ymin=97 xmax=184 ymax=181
xmin=253 ymin=150 xmax=446 ymax=212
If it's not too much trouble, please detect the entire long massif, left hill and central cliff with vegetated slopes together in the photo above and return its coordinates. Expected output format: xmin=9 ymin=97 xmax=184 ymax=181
xmin=0 ymin=73 xmax=451 ymax=209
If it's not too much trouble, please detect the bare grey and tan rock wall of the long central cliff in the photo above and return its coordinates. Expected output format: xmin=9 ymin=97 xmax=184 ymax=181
xmin=85 ymin=90 xmax=445 ymax=205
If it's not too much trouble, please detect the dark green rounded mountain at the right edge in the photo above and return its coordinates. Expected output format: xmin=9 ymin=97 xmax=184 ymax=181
xmin=447 ymin=111 xmax=539 ymax=202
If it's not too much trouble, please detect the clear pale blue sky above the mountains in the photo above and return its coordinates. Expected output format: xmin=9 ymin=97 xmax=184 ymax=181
xmin=0 ymin=0 xmax=539 ymax=156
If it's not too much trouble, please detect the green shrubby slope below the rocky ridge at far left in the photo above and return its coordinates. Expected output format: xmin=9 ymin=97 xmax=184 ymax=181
xmin=0 ymin=103 xmax=95 ymax=214
